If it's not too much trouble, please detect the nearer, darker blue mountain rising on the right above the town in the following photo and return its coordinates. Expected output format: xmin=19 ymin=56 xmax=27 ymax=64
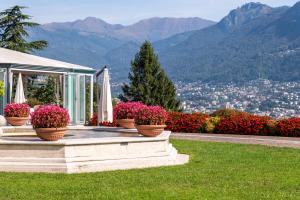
xmin=158 ymin=3 xmax=300 ymax=82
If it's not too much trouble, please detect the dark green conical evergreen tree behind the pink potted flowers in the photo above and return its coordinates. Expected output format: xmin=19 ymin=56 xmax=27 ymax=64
xmin=120 ymin=41 xmax=180 ymax=111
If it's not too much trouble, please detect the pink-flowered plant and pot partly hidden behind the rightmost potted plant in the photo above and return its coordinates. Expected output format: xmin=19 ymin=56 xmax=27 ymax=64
xmin=114 ymin=102 xmax=145 ymax=129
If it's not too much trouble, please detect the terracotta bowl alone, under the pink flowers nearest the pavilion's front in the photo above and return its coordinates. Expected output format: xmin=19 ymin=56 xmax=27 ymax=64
xmin=35 ymin=127 xmax=67 ymax=141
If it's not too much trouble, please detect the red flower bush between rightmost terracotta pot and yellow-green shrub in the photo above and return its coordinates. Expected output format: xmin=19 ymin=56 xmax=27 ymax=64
xmin=166 ymin=112 xmax=208 ymax=133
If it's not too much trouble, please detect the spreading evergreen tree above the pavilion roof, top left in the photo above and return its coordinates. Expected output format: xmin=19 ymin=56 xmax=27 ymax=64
xmin=0 ymin=6 xmax=48 ymax=53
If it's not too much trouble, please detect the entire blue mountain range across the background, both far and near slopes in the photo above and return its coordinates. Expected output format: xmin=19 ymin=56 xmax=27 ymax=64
xmin=30 ymin=3 xmax=300 ymax=82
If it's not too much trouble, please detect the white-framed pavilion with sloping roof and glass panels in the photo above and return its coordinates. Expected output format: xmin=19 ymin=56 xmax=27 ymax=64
xmin=0 ymin=48 xmax=95 ymax=124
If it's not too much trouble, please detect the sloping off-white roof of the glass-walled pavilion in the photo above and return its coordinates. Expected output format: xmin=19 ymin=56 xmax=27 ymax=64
xmin=0 ymin=48 xmax=95 ymax=72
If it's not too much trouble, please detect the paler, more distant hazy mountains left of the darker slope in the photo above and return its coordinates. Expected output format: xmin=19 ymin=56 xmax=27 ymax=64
xmin=30 ymin=17 xmax=215 ymax=76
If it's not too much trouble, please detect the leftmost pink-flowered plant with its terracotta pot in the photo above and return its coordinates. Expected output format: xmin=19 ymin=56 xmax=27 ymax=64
xmin=4 ymin=103 xmax=30 ymax=126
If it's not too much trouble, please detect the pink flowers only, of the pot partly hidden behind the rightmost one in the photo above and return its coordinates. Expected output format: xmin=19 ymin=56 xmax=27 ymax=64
xmin=114 ymin=102 xmax=145 ymax=119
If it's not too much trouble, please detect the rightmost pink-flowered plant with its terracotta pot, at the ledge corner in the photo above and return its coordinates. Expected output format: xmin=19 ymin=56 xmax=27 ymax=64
xmin=135 ymin=106 xmax=167 ymax=137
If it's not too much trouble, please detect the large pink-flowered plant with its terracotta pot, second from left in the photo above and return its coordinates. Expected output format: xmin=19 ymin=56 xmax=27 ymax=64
xmin=31 ymin=105 xmax=70 ymax=141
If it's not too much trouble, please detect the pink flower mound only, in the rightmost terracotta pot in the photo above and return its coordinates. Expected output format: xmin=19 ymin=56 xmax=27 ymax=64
xmin=134 ymin=106 xmax=168 ymax=125
